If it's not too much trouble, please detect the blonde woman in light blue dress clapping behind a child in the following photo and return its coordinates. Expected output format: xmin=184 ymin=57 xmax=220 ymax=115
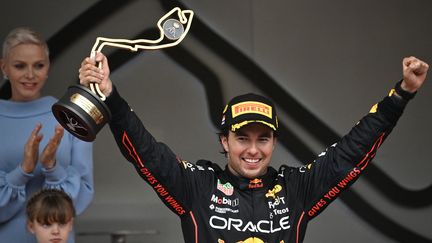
xmin=0 ymin=28 xmax=93 ymax=243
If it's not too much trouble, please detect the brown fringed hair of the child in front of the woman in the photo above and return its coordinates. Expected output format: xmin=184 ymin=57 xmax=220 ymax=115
xmin=26 ymin=189 xmax=75 ymax=225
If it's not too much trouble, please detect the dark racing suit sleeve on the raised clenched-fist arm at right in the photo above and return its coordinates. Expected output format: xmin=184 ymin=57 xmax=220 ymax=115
xmin=293 ymin=84 xmax=407 ymax=218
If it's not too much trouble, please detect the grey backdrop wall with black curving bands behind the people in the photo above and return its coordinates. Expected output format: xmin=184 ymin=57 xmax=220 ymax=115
xmin=0 ymin=0 xmax=432 ymax=243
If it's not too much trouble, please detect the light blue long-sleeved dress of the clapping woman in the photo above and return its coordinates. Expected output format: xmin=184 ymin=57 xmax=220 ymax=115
xmin=0 ymin=96 xmax=94 ymax=243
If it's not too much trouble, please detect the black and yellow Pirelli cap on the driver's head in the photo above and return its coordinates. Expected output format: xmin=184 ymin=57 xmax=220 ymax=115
xmin=220 ymin=93 xmax=278 ymax=132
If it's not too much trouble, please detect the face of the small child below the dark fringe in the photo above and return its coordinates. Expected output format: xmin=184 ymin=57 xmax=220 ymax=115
xmin=28 ymin=219 xmax=73 ymax=243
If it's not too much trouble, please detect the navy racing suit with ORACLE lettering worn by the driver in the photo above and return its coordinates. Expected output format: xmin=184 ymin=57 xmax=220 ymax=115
xmin=106 ymin=84 xmax=407 ymax=243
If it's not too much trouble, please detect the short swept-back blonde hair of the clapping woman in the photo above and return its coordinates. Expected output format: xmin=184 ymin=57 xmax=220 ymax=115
xmin=2 ymin=27 xmax=49 ymax=58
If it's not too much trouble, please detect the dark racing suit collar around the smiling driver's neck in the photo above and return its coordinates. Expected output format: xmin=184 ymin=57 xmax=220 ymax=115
xmin=225 ymin=165 xmax=277 ymax=190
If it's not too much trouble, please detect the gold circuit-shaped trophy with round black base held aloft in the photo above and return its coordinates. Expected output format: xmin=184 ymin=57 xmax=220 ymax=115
xmin=52 ymin=7 xmax=194 ymax=142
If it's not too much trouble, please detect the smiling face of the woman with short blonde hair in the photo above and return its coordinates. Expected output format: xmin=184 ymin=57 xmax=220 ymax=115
xmin=1 ymin=44 xmax=49 ymax=101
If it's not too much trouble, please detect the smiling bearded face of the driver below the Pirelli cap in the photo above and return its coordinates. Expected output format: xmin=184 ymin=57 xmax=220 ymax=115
xmin=220 ymin=123 xmax=276 ymax=179
